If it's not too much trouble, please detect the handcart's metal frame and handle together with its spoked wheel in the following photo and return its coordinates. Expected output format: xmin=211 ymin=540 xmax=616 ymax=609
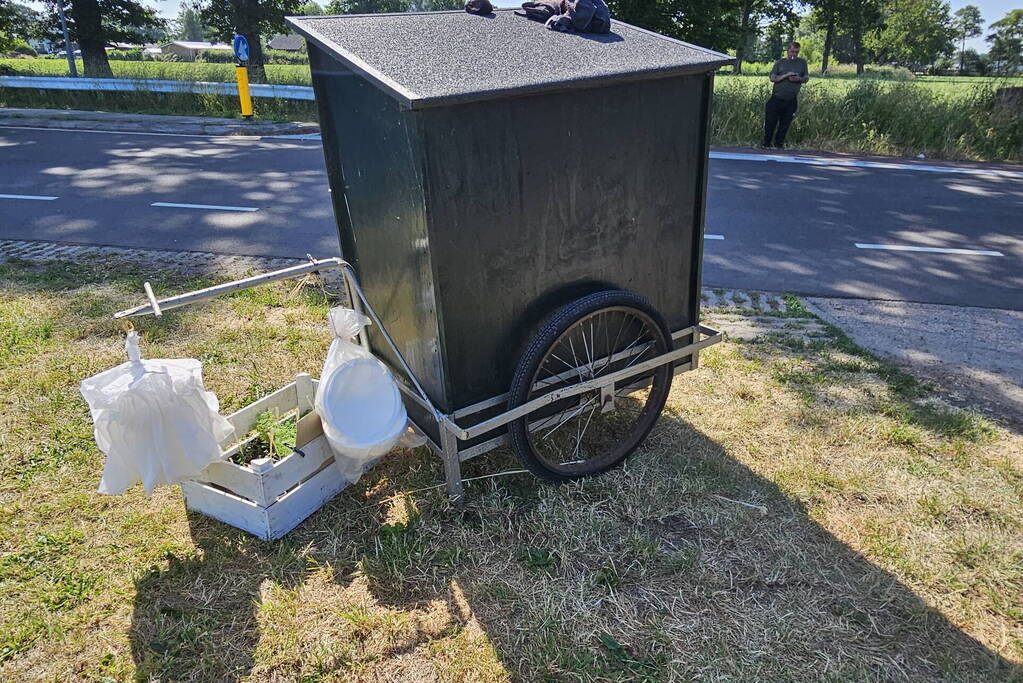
xmin=115 ymin=258 xmax=721 ymax=501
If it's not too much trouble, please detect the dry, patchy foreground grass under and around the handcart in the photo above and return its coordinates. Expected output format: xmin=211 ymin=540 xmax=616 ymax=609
xmin=0 ymin=258 xmax=1023 ymax=683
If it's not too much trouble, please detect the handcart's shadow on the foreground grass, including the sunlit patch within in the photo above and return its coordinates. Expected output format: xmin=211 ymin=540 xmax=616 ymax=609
xmin=130 ymin=411 xmax=1023 ymax=681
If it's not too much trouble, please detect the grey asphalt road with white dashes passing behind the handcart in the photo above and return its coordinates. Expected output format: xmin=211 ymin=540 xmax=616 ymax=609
xmin=0 ymin=128 xmax=1023 ymax=310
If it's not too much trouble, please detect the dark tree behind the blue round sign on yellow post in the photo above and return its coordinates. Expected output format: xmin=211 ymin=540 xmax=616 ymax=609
xmin=196 ymin=0 xmax=302 ymax=83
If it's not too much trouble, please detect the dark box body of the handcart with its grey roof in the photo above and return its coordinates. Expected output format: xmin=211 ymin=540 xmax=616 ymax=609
xmin=288 ymin=10 xmax=730 ymax=412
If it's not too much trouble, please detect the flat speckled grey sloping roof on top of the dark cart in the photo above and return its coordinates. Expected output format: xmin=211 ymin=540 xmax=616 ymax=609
xmin=287 ymin=9 xmax=733 ymax=109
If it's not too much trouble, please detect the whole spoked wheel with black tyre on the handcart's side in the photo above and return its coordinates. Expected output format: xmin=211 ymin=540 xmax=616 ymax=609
xmin=507 ymin=290 xmax=673 ymax=482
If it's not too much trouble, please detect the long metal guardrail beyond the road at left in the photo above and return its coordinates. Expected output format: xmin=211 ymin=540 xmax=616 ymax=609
xmin=0 ymin=76 xmax=313 ymax=100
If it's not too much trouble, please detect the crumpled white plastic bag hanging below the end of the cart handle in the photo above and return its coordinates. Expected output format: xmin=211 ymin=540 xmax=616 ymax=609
xmin=81 ymin=330 xmax=234 ymax=495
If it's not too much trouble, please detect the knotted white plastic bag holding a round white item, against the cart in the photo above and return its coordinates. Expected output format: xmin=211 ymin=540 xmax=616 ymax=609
xmin=314 ymin=307 xmax=408 ymax=483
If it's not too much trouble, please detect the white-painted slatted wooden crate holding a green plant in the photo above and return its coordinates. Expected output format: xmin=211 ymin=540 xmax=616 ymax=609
xmin=181 ymin=374 xmax=350 ymax=541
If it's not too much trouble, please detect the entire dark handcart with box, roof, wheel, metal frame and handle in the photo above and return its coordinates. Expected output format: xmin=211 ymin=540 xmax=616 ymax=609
xmin=114 ymin=9 xmax=733 ymax=507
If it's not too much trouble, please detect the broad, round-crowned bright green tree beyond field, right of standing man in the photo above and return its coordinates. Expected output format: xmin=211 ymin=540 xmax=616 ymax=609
xmin=866 ymin=0 xmax=954 ymax=69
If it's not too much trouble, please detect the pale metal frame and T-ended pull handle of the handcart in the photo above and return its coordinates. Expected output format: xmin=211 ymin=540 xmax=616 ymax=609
xmin=114 ymin=257 xmax=721 ymax=502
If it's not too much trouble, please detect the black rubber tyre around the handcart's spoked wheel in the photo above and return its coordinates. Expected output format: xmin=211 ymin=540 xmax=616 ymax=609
xmin=507 ymin=290 xmax=674 ymax=483
